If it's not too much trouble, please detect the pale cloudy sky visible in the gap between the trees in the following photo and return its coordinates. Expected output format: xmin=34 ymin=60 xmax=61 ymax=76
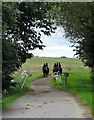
xmin=32 ymin=27 xmax=75 ymax=58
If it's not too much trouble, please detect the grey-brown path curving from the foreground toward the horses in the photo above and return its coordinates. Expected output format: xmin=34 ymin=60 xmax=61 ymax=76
xmin=3 ymin=77 xmax=91 ymax=118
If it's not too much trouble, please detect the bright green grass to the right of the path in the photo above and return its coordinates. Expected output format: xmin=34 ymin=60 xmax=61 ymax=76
xmin=49 ymin=70 xmax=94 ymax=115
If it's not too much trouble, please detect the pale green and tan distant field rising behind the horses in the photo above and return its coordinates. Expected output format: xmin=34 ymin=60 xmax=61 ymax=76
xmin=15 ymin=57 xmax=87 ymax=75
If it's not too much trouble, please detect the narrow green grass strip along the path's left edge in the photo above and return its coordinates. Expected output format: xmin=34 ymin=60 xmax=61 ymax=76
xmin=2 ymin=73 xmax=42 ymax=109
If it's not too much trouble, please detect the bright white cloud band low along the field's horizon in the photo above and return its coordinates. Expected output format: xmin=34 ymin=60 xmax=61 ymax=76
xmin=33 ymin=46 xmax=75 ymax=57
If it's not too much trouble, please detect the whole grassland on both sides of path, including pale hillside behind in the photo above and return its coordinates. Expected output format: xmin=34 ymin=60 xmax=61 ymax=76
xmin=3 ymin=57 xmax=94 ymax=114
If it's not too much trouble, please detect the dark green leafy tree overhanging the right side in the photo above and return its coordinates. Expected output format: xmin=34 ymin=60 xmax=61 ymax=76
xmin=52 ymin=2 xmax=94 ymax=79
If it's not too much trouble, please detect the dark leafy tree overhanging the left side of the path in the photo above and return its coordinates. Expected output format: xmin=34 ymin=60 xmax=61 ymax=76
xmin=2 ymin=2 xmax=55 ymax=89
